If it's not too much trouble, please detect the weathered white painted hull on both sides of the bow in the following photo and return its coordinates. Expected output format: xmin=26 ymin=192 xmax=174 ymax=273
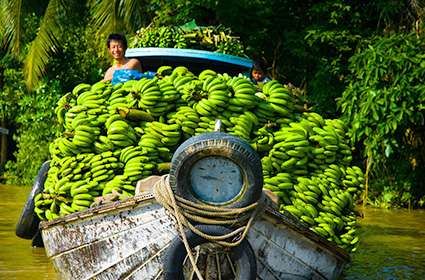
xmin=41 ymin=195 xmax=349 ymax=280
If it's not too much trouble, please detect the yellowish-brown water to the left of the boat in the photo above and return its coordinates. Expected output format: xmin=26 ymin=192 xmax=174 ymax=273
xmin=0 ymin=185 xmax=56 ymax=280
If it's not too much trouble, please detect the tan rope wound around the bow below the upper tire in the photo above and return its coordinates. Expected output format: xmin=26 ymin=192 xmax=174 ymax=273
xmin=153 ymin=175 xmax=263 ymax=280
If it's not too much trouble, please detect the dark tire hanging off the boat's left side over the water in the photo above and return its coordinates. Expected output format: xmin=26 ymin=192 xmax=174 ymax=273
xmin=15 ymin=160 xmax=50 ymax=239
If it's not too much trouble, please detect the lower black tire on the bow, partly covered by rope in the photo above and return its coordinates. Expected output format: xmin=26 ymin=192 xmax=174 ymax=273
xmin=163 ymin=225 xmax=257 ymax=280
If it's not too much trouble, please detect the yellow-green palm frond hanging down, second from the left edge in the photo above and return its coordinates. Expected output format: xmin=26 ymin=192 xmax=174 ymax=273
xmin=24 ymin=0 xmax=66 ymax=89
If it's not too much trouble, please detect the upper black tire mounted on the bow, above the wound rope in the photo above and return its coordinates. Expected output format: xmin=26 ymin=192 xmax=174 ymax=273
xmin=169 ymin=132 xmax=263 ymax=208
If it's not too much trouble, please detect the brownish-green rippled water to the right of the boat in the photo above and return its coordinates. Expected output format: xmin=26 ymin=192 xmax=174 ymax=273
xmin=344 ymin=209 xmax=425 ymax=280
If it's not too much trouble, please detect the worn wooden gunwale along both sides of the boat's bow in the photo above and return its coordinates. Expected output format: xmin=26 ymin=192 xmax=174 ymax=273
xmin=39 ymin=190 xmax=351 ymax=262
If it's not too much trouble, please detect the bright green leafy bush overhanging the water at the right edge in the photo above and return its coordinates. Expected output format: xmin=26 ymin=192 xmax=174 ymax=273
xmin=338 ymin=34 xmax=425 ymax=206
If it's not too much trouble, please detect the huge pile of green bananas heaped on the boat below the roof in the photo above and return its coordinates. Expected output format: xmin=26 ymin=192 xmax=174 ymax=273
xmin=35 ymin=66 xmax=364 ymax=250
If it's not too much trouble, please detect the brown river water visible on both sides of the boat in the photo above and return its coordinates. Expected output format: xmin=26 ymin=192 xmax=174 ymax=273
xmin=0 ymin=185 xmax=425 ymax=280
